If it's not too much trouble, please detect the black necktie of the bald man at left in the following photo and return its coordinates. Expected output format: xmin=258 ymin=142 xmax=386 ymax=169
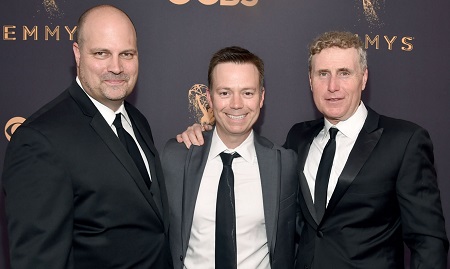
xmin=113 ymin=113 xmax=152 ymax=189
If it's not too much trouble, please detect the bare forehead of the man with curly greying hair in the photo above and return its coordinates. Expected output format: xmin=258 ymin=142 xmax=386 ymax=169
xmin=311 ymin=47 xmax=359 ymax=70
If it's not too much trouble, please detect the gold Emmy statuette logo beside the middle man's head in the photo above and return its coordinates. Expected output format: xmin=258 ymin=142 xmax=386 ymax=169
xmin=188 ymin=84 xmax=215 ymax=125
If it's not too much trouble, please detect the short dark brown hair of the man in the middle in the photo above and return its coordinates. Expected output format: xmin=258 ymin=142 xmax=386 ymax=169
xmin=208 ymin=46 xmax=264 ymax=89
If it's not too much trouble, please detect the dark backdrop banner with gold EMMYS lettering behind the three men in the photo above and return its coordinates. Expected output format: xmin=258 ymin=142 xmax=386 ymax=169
xmin=0 ymin=0 xmax=450 ymax=268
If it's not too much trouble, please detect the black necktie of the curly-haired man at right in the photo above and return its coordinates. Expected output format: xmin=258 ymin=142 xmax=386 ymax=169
xmin=314 ymin=128 xmax=339 ymax=221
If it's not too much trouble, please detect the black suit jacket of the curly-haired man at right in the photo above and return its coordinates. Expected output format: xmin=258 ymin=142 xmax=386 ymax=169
xmin=285 ymin=108 xmax=448 ymax=269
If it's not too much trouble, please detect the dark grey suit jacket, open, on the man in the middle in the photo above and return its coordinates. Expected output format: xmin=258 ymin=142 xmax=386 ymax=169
xmin=162 ymin=131 xmax=298 ymax=269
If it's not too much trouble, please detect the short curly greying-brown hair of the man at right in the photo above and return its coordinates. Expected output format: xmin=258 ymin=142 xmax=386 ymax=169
xmin=308 ymin=31 xmax=367 ymax=72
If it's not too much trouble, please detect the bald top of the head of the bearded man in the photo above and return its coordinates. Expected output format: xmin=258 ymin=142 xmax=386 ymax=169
xmin=75 ymin=5 xmax=136 ymax=46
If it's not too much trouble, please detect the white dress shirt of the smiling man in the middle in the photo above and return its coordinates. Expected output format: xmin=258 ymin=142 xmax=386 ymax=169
xmin=184 ymin=129 xmax=270 ymax=269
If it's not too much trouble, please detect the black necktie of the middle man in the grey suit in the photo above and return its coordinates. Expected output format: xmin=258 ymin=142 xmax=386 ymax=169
xmin=215 ymin=152 xmax=241 ymax=269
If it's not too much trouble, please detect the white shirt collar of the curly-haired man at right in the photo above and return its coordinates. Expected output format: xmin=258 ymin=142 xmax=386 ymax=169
xmin=323 ymin=101 xmax=367 ymax=140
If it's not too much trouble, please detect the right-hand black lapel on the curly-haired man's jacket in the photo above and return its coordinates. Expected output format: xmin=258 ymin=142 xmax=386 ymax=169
xmin=324 ymin=108 xmax=383 ymax=218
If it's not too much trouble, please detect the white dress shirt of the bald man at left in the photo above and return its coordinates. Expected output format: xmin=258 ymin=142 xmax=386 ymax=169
xmin=76 ymin=77 xmax=152 ymax=180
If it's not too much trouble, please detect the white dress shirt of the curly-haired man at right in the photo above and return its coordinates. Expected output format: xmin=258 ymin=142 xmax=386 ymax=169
xmin=303 ymin=101 xmax=367 ymax=206
